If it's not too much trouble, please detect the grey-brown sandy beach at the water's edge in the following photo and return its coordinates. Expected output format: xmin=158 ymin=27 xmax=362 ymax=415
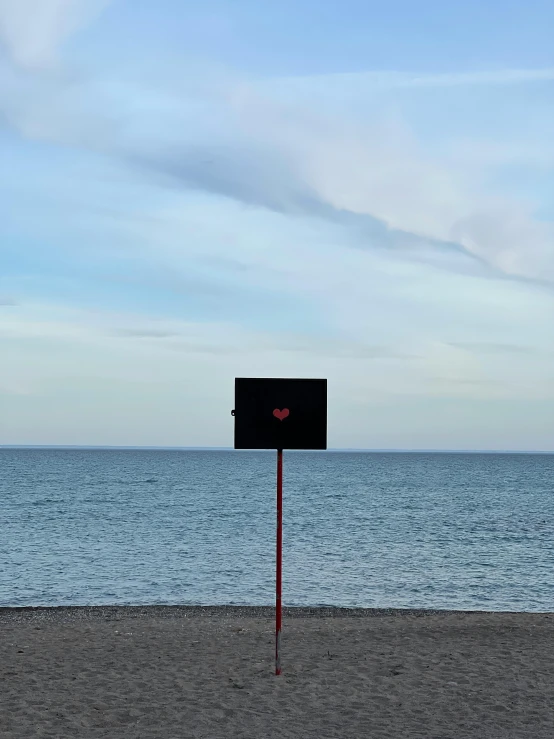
xmin=0 ymin=607 xmax=554 ymax=739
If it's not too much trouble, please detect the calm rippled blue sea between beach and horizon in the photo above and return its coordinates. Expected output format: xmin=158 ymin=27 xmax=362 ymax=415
xmin=0 ymin=449 xmax=554 ymax=611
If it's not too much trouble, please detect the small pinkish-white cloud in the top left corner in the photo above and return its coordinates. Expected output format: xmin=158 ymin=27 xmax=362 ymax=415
xmin=0 ymin=0 xmax=109 ymax=69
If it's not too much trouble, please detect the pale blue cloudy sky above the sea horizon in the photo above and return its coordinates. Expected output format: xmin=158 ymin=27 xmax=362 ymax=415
xmin=0 ymin=0 xmax=554 ymax=451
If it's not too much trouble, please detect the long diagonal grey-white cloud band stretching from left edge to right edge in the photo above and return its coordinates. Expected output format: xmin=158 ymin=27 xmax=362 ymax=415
xmin=0 ymin=49 xmax=554 ymax=281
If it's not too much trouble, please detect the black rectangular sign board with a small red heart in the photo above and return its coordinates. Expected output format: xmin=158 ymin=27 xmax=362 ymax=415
xmin=233 ymin=377 xmax=327 ymax=449
